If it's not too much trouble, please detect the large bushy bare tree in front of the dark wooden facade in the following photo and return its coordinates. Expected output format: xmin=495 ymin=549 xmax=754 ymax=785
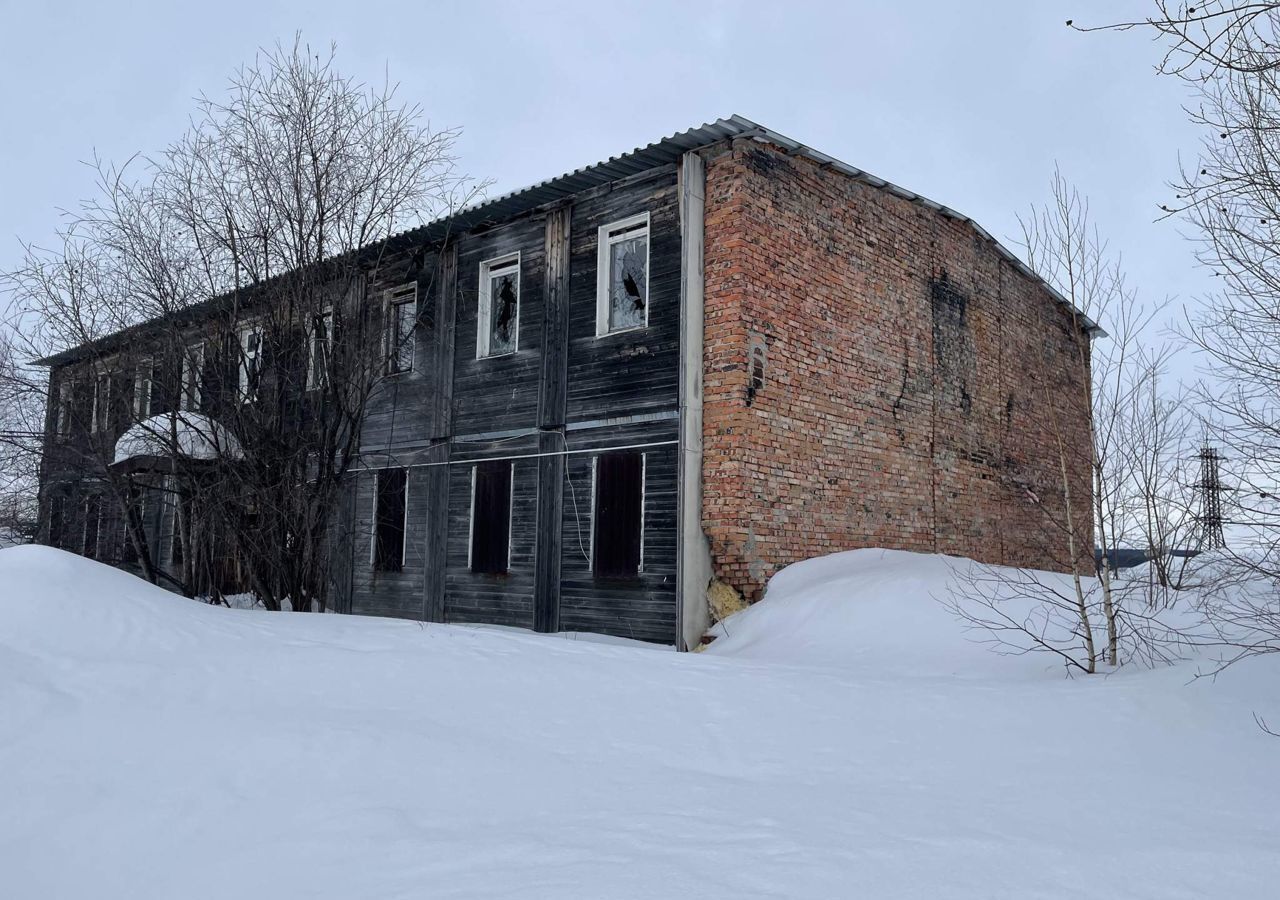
xmin=9 ymin=41 xmax=475 ymax=609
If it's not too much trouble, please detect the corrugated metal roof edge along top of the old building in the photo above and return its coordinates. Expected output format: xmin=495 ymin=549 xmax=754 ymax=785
xmin=38 ymin=115 xmax=1106 ymax=365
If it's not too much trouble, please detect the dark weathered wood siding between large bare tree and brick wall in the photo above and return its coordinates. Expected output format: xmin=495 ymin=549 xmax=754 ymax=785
xmin=349 ymin=166 xmax=680 ymax=643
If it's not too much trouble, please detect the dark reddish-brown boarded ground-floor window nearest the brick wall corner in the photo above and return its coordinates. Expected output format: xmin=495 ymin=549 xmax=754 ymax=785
xmin=591 ymin=452 xmax=644 ymax=577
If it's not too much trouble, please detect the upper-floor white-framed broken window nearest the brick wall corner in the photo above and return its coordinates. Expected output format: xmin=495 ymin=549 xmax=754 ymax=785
xmin=595 ymin=213 xmax=649 ymax=337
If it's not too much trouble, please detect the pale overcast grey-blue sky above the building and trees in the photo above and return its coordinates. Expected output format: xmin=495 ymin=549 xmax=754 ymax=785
xmin=0 ymin=0 xmax=1211 ymax=371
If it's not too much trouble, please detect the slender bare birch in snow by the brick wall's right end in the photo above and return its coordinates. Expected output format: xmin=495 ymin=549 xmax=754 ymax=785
xmin=947 ymin=173 xmax=1178 ymax=673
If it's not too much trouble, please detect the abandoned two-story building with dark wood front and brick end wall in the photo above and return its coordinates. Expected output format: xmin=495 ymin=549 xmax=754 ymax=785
xmin=42 ymin=117 xmax=1093 ymax=648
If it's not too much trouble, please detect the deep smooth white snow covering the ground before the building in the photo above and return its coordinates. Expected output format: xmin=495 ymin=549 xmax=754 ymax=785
xmin=0 ymin=547 xmax=1280 ymax=900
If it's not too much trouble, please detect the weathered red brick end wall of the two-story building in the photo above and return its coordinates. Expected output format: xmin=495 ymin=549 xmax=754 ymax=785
xmin=703 ymin=141 xmax=1088 ymax=600
